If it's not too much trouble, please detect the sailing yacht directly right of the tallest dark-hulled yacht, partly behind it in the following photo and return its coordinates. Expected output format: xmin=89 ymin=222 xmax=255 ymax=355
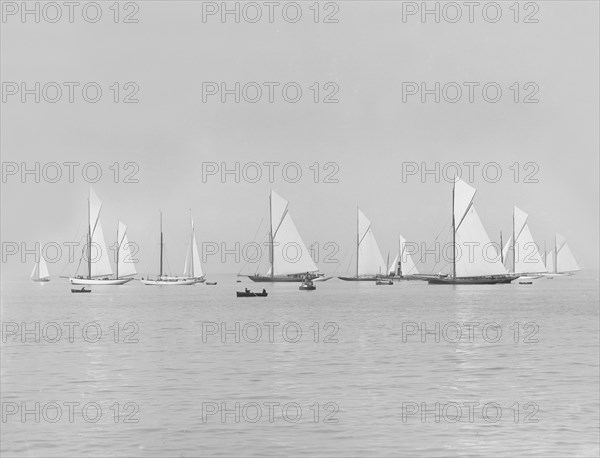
xmin=502 ymin=206 xmax=547 ymax=280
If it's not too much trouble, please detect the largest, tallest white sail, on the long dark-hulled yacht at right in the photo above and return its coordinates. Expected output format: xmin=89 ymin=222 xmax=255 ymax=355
xmin=454 ymin=178 xmax=506 ymax=277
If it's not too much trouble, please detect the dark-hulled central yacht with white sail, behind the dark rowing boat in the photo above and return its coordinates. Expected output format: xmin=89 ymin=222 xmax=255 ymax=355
xmin=248 ymin=190 xmax=323 ymax=282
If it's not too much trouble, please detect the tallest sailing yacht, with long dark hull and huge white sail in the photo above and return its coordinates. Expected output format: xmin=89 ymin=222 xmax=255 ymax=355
xmin=427 ymin=177 xmax=519 ymax=285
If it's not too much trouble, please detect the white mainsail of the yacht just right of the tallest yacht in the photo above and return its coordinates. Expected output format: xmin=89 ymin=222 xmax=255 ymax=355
xmin=509 ymin=206 xmax=546 ymax=274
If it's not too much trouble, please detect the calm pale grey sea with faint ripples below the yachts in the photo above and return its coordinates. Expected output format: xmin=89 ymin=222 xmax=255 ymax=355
xmin=1 ymin=273 xmax=600 ymax=457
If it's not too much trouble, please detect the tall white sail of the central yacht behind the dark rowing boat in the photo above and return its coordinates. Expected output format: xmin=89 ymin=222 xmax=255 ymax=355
xmin=271 ymin=191 xmax=319 ymax=275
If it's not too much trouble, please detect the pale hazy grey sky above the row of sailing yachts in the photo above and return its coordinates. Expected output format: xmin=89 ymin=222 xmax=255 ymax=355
xmin=0 ymin=1 xmax=600 ymax=278
